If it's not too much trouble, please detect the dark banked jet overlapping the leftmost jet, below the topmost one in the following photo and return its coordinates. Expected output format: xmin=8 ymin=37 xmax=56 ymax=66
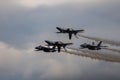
xmin=45 ymin=40 xmax=73 ymax=52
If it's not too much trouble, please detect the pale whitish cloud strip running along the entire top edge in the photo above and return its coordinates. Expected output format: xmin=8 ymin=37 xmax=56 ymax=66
xmin=1 ymin=0 xmax=119 ymax=8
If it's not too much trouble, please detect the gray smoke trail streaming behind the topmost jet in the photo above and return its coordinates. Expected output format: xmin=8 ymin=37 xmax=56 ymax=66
xmin=78 ymin=34 xmax=120 ymax=46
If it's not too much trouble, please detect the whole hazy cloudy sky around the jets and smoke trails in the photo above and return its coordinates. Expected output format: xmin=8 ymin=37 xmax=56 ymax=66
xmin=0 ymin=0 xmax=120 ymax=80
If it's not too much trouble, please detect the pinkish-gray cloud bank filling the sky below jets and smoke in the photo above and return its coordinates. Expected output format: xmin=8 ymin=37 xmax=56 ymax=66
xmin=0 ymin=42 xmax=120 ymax=80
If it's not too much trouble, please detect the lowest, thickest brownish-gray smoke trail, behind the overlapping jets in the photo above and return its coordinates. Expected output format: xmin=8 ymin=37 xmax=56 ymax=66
xmin=63 ymin=48 xmax=120 ymax=62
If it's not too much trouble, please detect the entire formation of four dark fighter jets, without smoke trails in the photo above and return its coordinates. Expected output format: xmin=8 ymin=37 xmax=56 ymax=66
xmin=35 ymin=27 xmax=107 ymax=52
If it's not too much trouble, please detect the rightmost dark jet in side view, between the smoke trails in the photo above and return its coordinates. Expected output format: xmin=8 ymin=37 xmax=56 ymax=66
xmin=80 ymin=41 xmax=107 ymax=50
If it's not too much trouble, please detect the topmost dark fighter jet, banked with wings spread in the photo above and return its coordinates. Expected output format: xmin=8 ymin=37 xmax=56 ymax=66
xmin=56 ymin=27 xmax=84 ymax=40
